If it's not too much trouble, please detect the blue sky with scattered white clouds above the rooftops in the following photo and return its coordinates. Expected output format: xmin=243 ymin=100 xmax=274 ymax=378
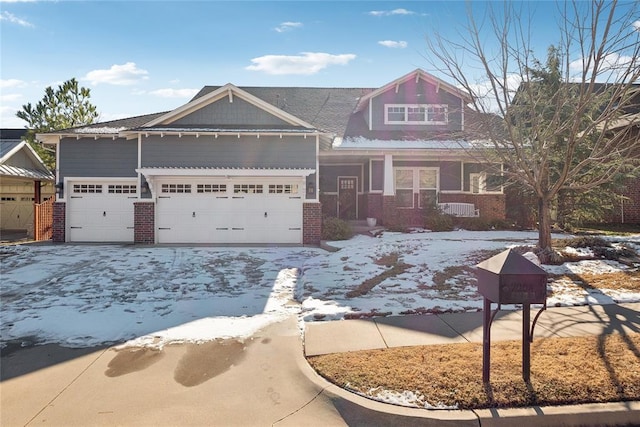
xmin=0 ymin=0 xmax=640 ymax=127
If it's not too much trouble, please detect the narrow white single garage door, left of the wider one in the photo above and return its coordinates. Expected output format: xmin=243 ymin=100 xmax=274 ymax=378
xmin=68 ymin=181 xmax=138 ymax=242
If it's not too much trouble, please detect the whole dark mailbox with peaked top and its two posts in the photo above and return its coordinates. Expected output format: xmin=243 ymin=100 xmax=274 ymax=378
xmin=476 ymin=249 xmax=547 ymax=383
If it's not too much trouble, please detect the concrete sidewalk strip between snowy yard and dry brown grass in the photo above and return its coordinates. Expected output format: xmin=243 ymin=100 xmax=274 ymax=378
xmin=304 ymin=302 xmax=640 ymax=356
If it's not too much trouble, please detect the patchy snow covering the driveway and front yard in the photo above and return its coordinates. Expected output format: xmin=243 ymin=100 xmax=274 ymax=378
xmin=0 ymin=231 xmax=640 ymax=347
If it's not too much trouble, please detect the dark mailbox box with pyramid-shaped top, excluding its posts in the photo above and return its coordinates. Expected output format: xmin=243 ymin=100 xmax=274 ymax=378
xmin=476 ymin=249 xmax=547 ymax=304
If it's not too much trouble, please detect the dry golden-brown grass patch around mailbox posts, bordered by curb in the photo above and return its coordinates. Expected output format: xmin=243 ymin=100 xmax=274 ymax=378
xmin=308 ymin=333 xmax=640 ymax=409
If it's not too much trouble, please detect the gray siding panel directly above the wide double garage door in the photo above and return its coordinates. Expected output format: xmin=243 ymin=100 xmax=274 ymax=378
xmin=142 ymin=135 xmax=316 ymax=169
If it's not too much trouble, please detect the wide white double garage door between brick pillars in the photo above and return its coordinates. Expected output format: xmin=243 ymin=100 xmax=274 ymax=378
xmin=156 ymin=178 xmax=304 ymax=244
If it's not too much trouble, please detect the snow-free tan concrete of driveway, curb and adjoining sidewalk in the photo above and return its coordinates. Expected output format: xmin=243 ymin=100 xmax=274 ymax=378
xmin=0 ymin=303 xmax=640 ymax=427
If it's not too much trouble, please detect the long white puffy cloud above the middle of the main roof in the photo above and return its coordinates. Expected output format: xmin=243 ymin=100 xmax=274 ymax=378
xmin=245 ymin=52 xmax=356 ymax=75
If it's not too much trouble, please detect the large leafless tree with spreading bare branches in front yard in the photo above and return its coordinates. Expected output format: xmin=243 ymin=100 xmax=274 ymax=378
xmin=427 ymin=0 xmax=640 ymax=248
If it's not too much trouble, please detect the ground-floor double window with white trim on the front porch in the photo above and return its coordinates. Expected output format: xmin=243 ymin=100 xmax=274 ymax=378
xmin=395 ymin=167 xmax=438 ymax=208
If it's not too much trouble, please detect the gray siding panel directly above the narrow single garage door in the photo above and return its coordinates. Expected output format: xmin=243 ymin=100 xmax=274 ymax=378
xmin=58 ymin=138 xmax=138 ymax=179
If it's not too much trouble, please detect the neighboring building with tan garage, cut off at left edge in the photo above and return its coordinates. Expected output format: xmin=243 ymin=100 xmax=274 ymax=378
xmin=0 ymin=129 xmax=54 ymax=237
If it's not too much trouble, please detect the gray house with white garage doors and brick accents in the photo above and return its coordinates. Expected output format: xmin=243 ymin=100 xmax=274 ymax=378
xmin=38 ymin=70 xmax=505 ymax=244
